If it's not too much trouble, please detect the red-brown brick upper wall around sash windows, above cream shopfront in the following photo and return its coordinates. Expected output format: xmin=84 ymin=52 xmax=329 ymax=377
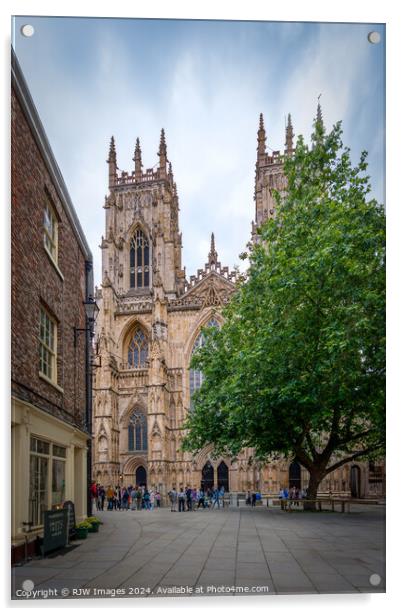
xmin=11 ymin=85 xmax=85 ymax=434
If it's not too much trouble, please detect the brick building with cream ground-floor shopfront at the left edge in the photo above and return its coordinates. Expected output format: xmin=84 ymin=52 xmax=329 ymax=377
xmin=11 ymin=54 xmax=93 ymax=560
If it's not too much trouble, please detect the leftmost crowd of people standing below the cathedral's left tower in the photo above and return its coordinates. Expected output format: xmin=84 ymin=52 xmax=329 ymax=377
xmin=91 ymin=483 xmax=161 ymax=511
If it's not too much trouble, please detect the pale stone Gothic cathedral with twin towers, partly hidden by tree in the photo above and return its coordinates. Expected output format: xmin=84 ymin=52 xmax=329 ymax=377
xmin=93 ymin=114 xmax=379 ymax=496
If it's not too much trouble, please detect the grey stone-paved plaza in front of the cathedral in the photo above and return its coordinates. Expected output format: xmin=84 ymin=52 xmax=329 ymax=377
xmin=12 ymin=506 xmax=385 ymax=598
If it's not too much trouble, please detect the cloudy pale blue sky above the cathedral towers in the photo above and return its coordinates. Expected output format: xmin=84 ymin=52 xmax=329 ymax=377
xmin=12 ymin=17 xmax=385 ymax=285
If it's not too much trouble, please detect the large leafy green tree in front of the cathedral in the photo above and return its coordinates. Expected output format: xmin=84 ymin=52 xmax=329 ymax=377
xmin=183 ymin=114 xmax=385 ymax=498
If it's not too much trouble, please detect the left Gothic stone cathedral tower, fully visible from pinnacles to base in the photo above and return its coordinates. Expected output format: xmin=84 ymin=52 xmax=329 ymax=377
xmin=94 ymin=129 xmax=185 ymax=484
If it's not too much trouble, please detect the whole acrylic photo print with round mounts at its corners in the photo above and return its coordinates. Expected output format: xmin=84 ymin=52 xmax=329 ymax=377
xmin=11 ymin=16 xmax=386 ymax=600
